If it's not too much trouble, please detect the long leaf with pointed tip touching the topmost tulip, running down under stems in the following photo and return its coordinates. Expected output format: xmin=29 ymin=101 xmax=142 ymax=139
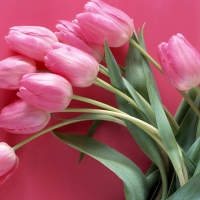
xmin=105 ymin=42 xmax=167 ymax=199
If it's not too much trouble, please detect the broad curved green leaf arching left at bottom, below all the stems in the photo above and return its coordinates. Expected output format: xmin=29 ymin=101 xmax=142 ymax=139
xmin=53 ymin=132 xmax=148 ymax=200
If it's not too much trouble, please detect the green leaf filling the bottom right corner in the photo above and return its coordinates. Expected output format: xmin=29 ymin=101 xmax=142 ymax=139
xmin=167 ymin=173 xmax=200 ymax=200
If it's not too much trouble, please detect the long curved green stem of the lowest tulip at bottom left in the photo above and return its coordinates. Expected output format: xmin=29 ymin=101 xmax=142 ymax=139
xmin=13 ymin=113 xmax=126 ymax=151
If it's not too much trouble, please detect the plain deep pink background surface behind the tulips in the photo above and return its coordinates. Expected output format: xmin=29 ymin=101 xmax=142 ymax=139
xmin=0 ymin=0 xmax=200 ymax=200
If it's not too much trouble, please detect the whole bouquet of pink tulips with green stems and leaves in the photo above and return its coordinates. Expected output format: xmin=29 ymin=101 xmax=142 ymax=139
xmin=0 ymin=0 xmax=200 ymax=200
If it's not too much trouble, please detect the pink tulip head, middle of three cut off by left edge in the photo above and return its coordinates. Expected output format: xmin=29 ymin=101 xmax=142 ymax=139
xmin=0 ymin=100 xmax=50 ymax=134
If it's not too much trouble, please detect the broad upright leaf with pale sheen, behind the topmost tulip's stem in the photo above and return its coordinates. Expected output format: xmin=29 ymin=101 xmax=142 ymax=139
xmin=125 ymin=33 xmax=149 ymax=102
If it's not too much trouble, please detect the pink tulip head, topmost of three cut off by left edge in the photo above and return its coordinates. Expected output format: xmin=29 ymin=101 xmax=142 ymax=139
xmin=0 ymin=55 xmax=36 ymax=90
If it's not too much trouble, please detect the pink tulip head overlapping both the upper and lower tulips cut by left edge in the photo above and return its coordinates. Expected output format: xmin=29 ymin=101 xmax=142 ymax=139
xmin=17 ymin=73 xmax=73 ymax=112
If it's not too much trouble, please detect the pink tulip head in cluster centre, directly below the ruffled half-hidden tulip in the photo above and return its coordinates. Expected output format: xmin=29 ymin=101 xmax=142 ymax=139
xmin=45 ymin=43 xmax=99 ymax=87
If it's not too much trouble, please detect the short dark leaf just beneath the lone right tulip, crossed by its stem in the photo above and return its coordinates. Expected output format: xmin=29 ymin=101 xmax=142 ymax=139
xmin=174 ymin=89 xmax=196 ymax=125
